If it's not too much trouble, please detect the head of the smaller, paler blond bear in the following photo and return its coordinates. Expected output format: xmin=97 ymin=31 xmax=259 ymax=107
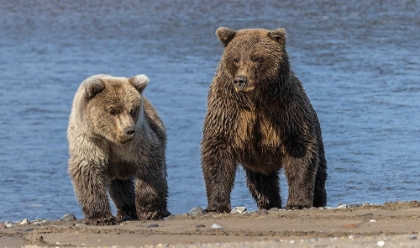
xmin=84 ymin=75 xmax=149 ymax=144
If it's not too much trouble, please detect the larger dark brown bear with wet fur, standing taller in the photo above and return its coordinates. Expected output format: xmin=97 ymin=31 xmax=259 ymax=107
xmin=201 ymin=27 xmax=327 ymax=212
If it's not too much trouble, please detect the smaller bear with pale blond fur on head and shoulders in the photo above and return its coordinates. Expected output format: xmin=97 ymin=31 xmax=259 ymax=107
xmin=67 ymin=75 xmax=169 ymax=225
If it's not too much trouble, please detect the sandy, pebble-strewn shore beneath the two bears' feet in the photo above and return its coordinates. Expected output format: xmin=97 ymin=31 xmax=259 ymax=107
xmin=0 ymin=201 xmax=420 ymax=247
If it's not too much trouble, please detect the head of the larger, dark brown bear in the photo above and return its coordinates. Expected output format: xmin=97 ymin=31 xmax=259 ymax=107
xmin=216 ymin=27 xmax=288 ymax=92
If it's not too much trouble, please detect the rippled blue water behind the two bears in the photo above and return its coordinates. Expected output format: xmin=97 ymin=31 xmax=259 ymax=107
xmin=0 ymin=0 xmax=420 ymax=222
